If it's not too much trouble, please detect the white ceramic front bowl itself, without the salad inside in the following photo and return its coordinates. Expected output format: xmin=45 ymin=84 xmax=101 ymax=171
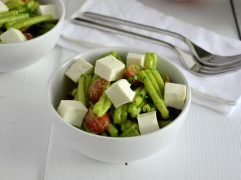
xmin=48 ymin=48 xmax=191 ymax=163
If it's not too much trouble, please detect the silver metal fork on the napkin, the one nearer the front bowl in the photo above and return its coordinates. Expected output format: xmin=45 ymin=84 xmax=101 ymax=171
xmin=72 ymin=12 xmax=241 ymax=75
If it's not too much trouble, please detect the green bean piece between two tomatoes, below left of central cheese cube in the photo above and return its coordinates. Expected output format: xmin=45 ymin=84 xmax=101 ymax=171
xmin=93 ymin=93 xmax=112 ymax=117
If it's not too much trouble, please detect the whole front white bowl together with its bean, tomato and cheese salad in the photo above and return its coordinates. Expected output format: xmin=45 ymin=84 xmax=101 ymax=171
xmin=48 ymin=47 xmax=191 ymax=162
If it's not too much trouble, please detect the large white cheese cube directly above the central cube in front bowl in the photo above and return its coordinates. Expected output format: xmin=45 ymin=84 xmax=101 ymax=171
xmin=95 ymin=55 xmax=125 ymax=81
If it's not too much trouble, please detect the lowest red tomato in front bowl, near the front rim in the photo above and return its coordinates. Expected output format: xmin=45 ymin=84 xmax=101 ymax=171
xmin=84 ymin=109 xmax=110 ymax=134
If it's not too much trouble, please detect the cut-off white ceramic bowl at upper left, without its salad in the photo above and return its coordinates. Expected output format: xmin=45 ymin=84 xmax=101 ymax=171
xmin=0 ymin=0 xmax=65 ymax=72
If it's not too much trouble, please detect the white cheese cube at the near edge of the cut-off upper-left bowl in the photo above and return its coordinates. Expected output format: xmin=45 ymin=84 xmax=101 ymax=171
xmin=0 ymin=28 xmax=27 ymax=44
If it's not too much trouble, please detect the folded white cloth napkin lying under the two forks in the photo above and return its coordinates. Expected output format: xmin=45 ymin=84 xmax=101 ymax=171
xmin=58 ymin=0 xmax=241 ymax=113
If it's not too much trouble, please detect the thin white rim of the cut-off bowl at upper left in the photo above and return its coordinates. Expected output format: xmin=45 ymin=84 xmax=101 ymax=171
xmin=0 ymin=0 xmax=66 ymax=48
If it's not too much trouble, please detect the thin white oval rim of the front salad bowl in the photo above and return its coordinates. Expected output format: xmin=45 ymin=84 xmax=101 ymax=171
xmin=47 ymin=46 xmax=192 ymax=141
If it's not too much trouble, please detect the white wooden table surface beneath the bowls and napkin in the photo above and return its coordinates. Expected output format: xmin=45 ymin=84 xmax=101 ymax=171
xmin=0 ymin=0 xmax=241 ymax=180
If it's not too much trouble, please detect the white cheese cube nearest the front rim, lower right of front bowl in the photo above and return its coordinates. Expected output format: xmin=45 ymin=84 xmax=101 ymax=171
xmin=137 ymin=111 xmax=159 ymax=134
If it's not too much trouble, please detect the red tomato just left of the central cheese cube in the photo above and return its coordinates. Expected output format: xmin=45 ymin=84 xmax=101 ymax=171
xmin=89 ymin=78 xmax=109 ymax=103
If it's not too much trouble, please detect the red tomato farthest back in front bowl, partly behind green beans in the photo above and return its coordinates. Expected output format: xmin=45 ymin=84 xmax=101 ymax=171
xmin=126 ymin=64 xmax=142 ymax=86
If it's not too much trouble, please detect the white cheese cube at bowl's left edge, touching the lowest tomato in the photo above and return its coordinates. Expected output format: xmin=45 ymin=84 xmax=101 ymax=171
xmin=57 ymin=100 xmax=88 ymax=127
